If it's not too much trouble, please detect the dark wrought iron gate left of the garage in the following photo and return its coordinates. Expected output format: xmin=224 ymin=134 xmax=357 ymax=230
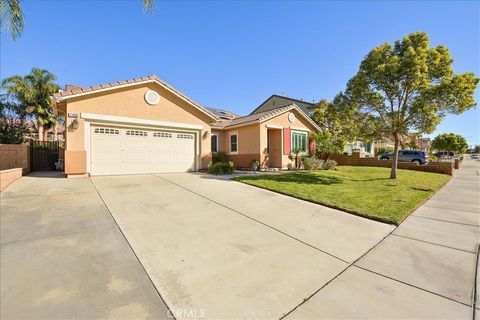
xmin=30 ymin=141 xmax=60 ymax=171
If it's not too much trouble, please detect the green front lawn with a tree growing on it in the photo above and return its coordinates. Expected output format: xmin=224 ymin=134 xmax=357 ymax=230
xmin=234 ymin=166 xmax=450 ymax=225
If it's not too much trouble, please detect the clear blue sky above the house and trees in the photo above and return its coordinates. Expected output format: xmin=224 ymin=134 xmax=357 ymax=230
xmin=0 ymin=0 xmax=480 ymax=144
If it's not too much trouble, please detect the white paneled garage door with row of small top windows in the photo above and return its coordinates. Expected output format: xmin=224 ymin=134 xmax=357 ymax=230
xmin=90 ymin=126 xmax=195 ymax=175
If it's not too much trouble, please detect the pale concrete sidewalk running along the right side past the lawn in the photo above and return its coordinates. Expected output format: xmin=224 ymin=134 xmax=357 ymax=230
xmin=287 ymin=160 xmax=480 ymax=319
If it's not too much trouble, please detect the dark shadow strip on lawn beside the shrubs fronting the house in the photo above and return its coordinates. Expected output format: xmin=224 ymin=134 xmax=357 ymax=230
xmin=234 ymin=172 xmax=345 ymax=185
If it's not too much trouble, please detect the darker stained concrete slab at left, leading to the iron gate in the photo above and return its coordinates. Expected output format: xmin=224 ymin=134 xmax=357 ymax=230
xmin=0 ymin=174 xmax=168 ymax=319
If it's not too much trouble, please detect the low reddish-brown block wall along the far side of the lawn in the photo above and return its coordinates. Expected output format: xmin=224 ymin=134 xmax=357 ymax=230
xmin=330 ymin=152 xmax=460 ymax=176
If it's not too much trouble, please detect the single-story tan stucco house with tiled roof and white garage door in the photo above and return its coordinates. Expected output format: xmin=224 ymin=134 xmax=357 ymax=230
xmin=54 ymin=75 xmax=319 ymax=176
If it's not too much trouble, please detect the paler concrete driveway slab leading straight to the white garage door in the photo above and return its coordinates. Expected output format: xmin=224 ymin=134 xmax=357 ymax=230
xmin=92 ymin=174 xmax=393 ymax=319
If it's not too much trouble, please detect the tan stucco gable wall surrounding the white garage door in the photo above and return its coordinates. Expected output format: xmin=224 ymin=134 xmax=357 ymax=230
xmin=65 ymin=83 xmax=212 ymax=174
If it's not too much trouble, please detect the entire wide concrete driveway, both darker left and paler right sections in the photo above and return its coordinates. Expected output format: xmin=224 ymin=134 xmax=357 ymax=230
xmin=0 ymin=174 xmax=393 ymax=319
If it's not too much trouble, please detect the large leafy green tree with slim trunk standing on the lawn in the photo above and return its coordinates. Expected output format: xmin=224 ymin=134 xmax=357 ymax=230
xmin=339 ymin=32 xmax=479 ymax=179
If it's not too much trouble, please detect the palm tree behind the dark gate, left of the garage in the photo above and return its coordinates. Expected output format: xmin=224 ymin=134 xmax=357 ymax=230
xmin=2 ymin=68 xmax=60 ymax=140
